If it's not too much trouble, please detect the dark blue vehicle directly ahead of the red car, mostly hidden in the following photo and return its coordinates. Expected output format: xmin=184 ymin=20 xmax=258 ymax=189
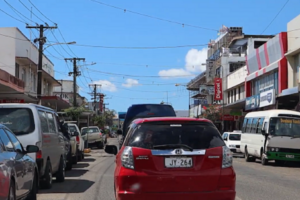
xmin=119 ymin=104 xmax=176 ymax=148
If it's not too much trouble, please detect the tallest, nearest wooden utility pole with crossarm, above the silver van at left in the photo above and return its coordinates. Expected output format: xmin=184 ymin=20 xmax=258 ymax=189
xmin=26 ymin=24 xmax=57 ymax=104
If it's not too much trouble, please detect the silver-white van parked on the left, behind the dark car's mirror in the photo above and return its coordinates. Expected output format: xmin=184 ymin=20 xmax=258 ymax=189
xmin=0 ymin=103 xmax=66 ymax=189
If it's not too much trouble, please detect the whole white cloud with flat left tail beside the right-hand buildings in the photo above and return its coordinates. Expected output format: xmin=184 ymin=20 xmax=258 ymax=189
xmin=158 ymin=48 xmax=207 ymax=79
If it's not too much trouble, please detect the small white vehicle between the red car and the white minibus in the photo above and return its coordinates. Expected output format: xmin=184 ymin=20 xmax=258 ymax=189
xmin=222 ymin=131 xmax=241 ymax=153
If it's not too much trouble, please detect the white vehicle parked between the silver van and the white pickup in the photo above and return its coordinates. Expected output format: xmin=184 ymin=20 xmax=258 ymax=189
xmin=66 ymin=122 xmax=84 ymax=164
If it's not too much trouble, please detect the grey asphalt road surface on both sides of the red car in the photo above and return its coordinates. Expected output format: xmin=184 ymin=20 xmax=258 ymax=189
xmin=38 ymin=139 xmax=300 ymax=200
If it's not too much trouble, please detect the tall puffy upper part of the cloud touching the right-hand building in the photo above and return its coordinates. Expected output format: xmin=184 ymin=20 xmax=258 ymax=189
xmin=185 ymin=48 xmax=207 ymax=72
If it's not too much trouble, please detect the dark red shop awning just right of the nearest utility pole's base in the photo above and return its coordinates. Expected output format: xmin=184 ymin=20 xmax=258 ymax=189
xmin=41 ymin=96 xmax=71 ymax=111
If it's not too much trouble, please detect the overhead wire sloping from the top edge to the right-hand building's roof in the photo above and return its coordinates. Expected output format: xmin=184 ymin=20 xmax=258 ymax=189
xmin=91 ymin=0 xmax=218 ymax=31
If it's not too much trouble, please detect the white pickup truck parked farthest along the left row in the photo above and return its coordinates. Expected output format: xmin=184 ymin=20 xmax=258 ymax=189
xmin=81 ymin=126 xmax=104 ymax=149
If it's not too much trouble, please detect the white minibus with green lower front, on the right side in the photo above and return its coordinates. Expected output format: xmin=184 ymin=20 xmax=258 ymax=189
xmin=240 ymin=110 xmax=300 ymax=165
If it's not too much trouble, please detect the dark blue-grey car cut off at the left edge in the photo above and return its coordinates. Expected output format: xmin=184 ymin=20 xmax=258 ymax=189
xmin=0 ymin=125 xmax=39 ymax=200
